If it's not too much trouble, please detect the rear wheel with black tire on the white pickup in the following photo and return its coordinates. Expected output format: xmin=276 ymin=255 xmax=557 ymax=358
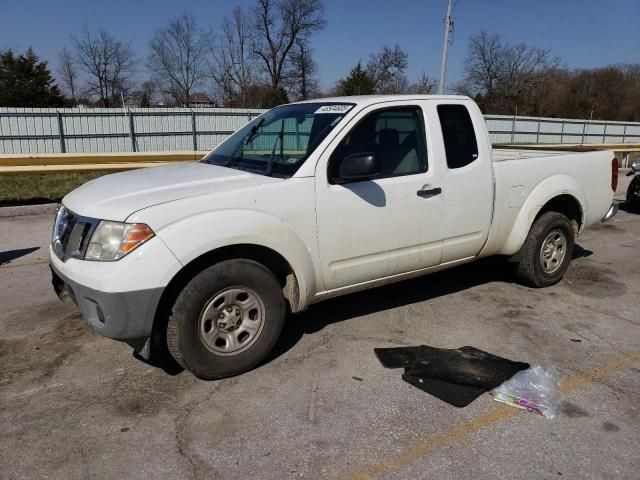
xmin=516 ymin=212 xmax=575 ymax=288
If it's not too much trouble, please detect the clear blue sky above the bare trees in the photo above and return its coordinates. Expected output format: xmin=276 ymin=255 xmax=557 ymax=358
xmin=0 ymin=0 xmax=640 ymax=88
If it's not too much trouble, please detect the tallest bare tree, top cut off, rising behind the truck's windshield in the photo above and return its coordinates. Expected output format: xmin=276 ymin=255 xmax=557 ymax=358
xmin=254 ymin=0 xmax=326 ymax=103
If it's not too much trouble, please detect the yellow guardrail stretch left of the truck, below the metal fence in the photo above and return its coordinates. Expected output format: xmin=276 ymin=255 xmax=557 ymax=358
xmin=0 ymin=151 xmax=207 ymax=175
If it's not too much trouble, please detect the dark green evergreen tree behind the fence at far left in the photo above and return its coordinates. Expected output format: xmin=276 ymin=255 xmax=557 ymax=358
xmin=0 ymin=48 xmax=64 ymax=107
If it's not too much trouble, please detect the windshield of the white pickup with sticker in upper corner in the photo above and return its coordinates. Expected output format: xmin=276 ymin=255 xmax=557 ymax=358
xmin=203 ymin=102 xmax=353 ymax=178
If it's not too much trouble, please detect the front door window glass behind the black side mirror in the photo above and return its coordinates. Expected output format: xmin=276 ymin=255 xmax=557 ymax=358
xmin=329 ymin=107 xmax=427 ymax=180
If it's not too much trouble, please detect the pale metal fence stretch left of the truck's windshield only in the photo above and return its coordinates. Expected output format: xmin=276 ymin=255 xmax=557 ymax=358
xmin=0 ymin=108 xmax=263 ymax=154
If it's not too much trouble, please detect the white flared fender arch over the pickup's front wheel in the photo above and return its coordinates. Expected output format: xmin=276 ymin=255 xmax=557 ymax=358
xmin=156 ymin=209 xmax=317 ymax=306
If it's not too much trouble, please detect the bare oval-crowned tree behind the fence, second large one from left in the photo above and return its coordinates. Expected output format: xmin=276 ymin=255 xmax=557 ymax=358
xmin=147 ymin=13 xmax=211 ymax=105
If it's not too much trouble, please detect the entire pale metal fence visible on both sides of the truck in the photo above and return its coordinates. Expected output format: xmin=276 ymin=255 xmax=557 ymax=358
xmin=0 ymin=108 xmax=640 ymax=154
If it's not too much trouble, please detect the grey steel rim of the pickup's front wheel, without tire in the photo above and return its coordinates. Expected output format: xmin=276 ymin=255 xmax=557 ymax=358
xmin=199 ymin=287 xmax=265 ymax=355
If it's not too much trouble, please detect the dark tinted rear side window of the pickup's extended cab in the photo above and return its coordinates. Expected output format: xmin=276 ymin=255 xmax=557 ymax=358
xmin=438 ymin=105 xmax=478 ymax=168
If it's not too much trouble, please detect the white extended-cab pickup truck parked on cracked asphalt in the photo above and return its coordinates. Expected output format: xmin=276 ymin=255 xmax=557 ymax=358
xmin=50 ymin=96 xmax=618 ymax=379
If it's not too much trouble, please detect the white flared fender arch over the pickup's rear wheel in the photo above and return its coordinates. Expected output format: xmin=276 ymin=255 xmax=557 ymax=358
xmin=500 ymin=174 xmax=587 ymax=255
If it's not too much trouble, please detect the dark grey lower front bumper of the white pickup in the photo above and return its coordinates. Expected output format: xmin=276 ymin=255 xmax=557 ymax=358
xmin=51 ymin=265 xmax=164 ymax=343
